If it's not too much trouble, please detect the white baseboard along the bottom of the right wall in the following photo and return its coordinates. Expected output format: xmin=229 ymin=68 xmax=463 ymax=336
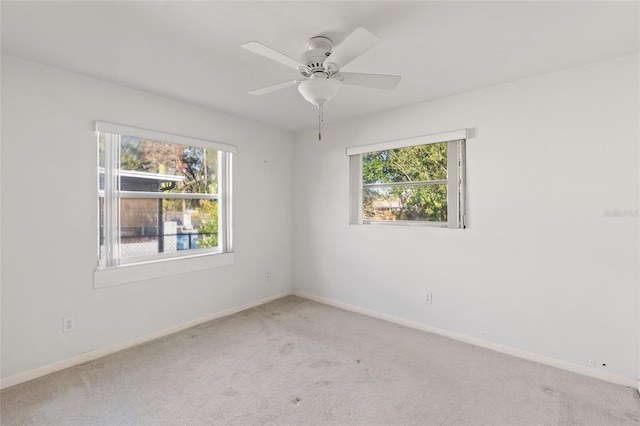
xmin=293 ymin=290 xmax=640 ymax=391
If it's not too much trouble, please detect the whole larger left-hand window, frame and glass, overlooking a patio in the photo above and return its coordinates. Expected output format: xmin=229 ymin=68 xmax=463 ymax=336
xmin=96 ymin=122 xmax=235 ymax=285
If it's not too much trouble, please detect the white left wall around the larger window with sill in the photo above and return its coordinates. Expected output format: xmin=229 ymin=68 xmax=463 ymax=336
xmin=1 ymin=56 xmax=293 ymax=377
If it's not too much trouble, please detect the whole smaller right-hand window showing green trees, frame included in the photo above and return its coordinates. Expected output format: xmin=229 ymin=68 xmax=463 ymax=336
xmin=347 ymin=130 xmax=466 ymax=228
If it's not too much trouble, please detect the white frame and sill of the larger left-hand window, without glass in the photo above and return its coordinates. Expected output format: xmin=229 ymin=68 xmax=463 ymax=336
xmin=94 ymin=121 xmax=236 ymax=288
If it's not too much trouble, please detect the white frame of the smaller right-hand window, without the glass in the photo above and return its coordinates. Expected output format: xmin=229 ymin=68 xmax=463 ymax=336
xmin=347 ymin=129 xmax=467 ymax=229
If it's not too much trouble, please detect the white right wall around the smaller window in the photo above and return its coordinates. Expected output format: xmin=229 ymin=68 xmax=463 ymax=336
xmin=294 ymin=55 xmax=640 ymax=378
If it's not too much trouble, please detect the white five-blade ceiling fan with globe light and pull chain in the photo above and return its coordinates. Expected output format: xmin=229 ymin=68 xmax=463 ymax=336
xmin=241 ymin=27 xmax=400 ymax=139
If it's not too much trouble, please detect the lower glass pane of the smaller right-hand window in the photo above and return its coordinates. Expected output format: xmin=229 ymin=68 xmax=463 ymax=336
xmin=362 ymin=184 xmax=447 ymax=222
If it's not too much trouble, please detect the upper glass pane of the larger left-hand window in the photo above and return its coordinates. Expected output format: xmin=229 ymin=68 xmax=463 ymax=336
xmin=120 ymin=136 xmax=218 ymax=194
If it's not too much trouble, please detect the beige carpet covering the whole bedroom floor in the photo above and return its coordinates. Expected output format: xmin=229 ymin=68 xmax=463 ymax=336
xmin=0 ymin=297 xmax=640 ymax=426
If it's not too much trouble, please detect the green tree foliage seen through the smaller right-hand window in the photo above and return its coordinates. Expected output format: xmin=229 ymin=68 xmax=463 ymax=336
xmin=362 ymin=142 xmax=447 ymax=221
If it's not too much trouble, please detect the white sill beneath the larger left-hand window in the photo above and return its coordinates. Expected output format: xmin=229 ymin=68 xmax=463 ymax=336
xmin=93 ymin=253 xmax=235 ymax=288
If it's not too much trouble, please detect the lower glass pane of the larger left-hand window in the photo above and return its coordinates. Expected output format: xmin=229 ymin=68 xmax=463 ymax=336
xmin=107 ymin=198 xmax=218 ymax=258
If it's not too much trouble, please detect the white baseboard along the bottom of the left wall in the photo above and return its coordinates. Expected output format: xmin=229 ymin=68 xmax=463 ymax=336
xmin=0 ymin=291 xmax=293 ymax=389
